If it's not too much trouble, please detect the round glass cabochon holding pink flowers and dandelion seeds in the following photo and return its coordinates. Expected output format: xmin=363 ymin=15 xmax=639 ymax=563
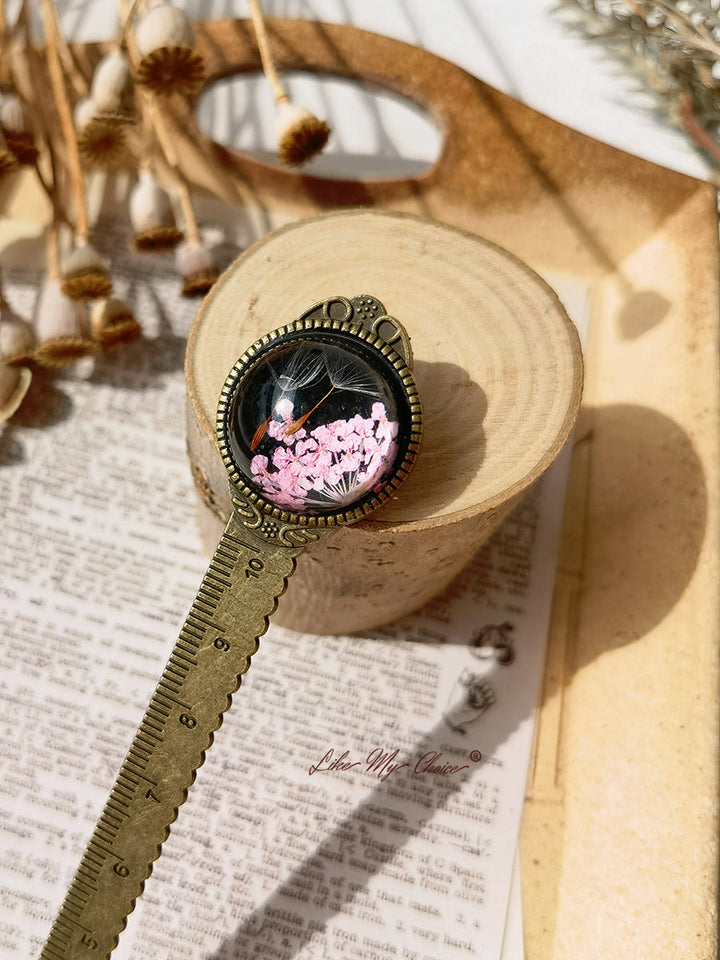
xmin=228 ymin=331 xmax=410 ymax=514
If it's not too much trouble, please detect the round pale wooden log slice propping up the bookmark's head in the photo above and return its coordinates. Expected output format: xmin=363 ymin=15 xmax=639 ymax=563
xmin=185 ymin=210 xmax=582 ymax=634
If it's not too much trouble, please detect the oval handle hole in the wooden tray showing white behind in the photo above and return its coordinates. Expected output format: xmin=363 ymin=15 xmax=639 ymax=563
xmin=196 ymin=72 xmax=442 ymax=180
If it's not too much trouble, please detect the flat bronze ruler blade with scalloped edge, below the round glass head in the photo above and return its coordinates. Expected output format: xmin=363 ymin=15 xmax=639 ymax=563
xmin=41 ymin=513 xmax=302 ymax=960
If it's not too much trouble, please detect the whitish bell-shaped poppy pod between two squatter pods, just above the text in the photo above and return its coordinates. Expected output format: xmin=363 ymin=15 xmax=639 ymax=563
xmin=34 ymin=280 xmax=99 ymax=367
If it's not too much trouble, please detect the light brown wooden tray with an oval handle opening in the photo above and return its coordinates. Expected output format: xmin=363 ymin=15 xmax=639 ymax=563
xmin=2 ymin=20 xmax=718 ymax=960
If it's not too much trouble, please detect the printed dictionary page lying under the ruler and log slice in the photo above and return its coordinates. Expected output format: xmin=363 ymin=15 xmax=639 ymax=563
xmin=0 ymin=212 xmax=584 ymax=960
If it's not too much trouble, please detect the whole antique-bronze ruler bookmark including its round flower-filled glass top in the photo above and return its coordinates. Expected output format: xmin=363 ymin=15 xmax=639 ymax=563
xmin=40 ymin=294 xmax=422 ymax=960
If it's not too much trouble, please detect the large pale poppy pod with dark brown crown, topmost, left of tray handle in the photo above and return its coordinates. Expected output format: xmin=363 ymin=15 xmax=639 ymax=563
xmin=135 ymin=3 xmax=205 ymax=96
